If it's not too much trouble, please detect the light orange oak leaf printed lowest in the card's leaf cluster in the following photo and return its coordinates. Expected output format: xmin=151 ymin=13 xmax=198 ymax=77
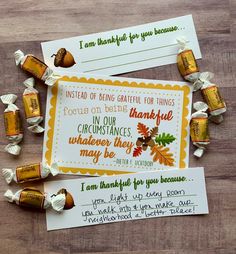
xmin=151 ymin=145 xmax=175 ymax=166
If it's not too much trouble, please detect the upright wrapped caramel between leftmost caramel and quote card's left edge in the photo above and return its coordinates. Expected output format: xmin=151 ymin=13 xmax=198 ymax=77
xmin=23 ymin=78 xmax=44 ymax=133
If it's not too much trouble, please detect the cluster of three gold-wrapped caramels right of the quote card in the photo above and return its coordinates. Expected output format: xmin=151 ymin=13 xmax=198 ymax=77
xmin=177 ymin=37 xmax=226 ymax=157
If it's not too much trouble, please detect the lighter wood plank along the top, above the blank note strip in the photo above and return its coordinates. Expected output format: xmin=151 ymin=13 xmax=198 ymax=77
xmin=0 ymin=0 xmax=230 ymax=42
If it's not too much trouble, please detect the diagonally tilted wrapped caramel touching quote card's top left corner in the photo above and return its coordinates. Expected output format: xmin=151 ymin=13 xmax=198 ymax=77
xmin=14 ymin=50 xmax=59 ymax=86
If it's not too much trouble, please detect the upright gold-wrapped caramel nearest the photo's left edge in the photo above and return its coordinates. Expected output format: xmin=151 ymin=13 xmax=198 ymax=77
xmin=0 ymin=94 xmax=23 ymax=155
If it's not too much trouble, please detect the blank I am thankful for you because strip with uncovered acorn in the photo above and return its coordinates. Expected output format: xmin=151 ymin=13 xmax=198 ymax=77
xmin=41 ymin=15 xmax=201 ymax=75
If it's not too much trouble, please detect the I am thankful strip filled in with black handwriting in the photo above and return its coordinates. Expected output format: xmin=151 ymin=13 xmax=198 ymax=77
xmin=44 ymin=168 xmax=208 ymax=230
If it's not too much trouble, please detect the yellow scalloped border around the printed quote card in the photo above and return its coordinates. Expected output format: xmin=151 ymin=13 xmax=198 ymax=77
xmin=43 ymin=76 xmax=191 ymax=176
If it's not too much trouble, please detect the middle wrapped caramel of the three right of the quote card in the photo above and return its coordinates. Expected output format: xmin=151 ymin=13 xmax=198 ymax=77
xmin=193 ymin=72 xmax=226 ymax=123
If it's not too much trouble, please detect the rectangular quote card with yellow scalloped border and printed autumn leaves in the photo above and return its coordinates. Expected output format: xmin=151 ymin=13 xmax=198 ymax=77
xmin=43 ymin=74 xmax=192 ymax=175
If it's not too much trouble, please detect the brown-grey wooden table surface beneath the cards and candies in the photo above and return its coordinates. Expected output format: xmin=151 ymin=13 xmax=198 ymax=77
xmin=0 ymin=0 xmax=236 ymax=254
